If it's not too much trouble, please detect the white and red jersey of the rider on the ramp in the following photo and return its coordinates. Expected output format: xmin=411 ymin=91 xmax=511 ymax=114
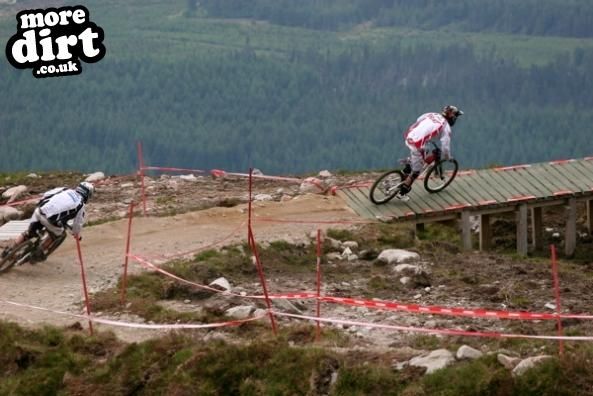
xmin=404 ymin=113 xmax=451 ymax=153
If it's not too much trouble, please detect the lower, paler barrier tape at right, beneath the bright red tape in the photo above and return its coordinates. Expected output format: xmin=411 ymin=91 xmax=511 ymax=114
xmin=272 ymin=311 xmax=593 ymax=341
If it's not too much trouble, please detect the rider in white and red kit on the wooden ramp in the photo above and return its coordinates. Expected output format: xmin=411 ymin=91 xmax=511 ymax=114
xmin=397 ymin=105 xmax=463 ymax=198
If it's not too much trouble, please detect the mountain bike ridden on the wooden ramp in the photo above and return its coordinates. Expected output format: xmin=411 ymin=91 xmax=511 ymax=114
xmin=369 ymin=142 xmax=459 ymax=205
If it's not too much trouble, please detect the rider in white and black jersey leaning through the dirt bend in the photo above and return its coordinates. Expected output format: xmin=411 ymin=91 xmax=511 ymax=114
xmin=1 ymin=182 xmax=95 ymax=257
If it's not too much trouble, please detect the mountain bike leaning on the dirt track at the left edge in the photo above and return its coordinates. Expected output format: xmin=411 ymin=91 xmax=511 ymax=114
xmin=0 ymin=227 xmax=69 ymax=273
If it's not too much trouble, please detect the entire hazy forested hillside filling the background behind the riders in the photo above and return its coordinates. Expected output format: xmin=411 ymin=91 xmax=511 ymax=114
xmin=0 ymin=0 xmax=593 ymax=173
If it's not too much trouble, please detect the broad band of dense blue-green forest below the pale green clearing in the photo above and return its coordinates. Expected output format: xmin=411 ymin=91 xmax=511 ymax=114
xmin=0 ymin=37 xmax=593 ymax=173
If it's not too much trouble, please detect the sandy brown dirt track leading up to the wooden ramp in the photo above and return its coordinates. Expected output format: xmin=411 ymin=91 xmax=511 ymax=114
xmin=0 ymin=195 xmax=360 ymax=341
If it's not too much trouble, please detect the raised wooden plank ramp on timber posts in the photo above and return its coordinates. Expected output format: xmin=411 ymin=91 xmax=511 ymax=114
xmin=337 ymin=157 xmax=593 ymax=254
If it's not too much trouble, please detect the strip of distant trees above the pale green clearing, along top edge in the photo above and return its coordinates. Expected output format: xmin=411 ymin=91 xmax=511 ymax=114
xmin=200 ymin=0 xmax=593 ymax=37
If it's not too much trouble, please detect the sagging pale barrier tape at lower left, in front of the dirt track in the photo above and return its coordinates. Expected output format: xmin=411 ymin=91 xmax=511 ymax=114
xmin=0 ymin=300 xmax=268 ymax=330
